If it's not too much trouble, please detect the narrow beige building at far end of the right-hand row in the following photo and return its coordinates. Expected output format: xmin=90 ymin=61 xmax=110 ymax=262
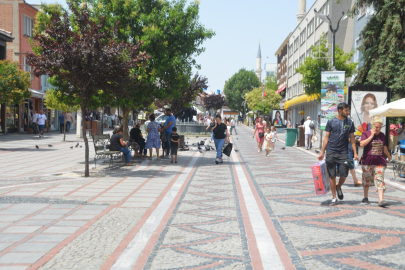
xmin=275 ymin=33 xmax=291 ymax=109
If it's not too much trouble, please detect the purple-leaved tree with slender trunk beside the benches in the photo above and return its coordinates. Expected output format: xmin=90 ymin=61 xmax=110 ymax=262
xmin=27 ymin=3 xmax=149 ymax=177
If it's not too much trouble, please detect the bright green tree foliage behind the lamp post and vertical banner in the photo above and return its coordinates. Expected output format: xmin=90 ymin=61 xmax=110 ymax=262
xmin=295 ymin=37 xmax=357 ymax=95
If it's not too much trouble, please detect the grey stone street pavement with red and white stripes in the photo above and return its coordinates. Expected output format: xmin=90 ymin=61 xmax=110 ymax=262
xmin=0 ymin=126 xmax=405 ymax=270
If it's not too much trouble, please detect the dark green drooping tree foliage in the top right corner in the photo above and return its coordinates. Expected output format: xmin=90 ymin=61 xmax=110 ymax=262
xmin=351 ymin=0 xmax=405 ymax=98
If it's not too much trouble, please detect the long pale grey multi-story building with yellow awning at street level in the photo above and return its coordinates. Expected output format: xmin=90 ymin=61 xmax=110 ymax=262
xmin=284 ymin=0 xmax=353 ymax=127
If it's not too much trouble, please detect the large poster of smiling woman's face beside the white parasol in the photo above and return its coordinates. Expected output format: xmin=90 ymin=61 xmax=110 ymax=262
xmin=350 ymin=91 xmax=387 ymax=136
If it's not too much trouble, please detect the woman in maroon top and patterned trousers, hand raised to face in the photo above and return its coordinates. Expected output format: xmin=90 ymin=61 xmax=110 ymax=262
xmin=360 ymin=117 xmax=392 ymax=207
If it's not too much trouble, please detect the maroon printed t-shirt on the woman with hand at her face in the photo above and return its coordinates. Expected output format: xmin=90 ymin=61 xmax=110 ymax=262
xmin=361 ymin=131 xmax=387 ymax=166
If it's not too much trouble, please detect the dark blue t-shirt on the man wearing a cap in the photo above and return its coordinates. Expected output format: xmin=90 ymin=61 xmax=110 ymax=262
xmin=325 ymin=117 xmax=354 ymax=154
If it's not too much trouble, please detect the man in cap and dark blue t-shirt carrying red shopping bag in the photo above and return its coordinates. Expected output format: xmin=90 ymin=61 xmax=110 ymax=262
xmin=318 ymin=103 xmax=359 ymax=205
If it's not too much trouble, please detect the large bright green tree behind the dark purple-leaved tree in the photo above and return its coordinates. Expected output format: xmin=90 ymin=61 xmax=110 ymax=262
xmin=73 ymin=0 xmax=215 ymax=122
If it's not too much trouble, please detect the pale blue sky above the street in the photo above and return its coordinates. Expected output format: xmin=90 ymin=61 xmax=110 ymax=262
xmin=26 ymin=0 xmax=315 ymax=92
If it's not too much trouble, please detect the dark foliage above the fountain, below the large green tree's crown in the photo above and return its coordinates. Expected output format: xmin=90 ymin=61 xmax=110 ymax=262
xmin=155 ymin=73 xmax=208 ymax=115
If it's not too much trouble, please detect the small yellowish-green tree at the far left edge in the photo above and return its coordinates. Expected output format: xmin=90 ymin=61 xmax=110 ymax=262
xmin=0 ymin=60 xmax=31 ymax=104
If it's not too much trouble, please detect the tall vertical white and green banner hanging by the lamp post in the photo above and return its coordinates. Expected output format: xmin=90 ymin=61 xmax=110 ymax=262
xmin=321 ymin=71 xmax=345 ymax=130
